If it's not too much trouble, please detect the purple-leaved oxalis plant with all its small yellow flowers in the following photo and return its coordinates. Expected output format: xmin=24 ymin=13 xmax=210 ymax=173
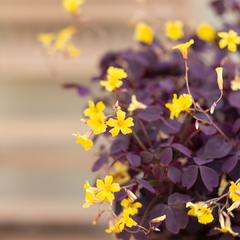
xmin=39 ymin=0 xmax=240 ymax=240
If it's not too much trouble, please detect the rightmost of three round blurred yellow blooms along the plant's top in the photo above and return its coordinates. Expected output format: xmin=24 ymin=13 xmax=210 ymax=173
xmin=197 ymin=22 xmax=216 ymax=42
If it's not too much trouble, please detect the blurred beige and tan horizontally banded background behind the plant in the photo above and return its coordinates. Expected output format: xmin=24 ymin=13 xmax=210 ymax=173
xmin=0 ymin=0 xmax=214 ymax=240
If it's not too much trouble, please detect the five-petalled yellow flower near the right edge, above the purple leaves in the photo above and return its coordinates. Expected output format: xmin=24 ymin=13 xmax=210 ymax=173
xmin=218 ymin=30 xmax=240 ymax=52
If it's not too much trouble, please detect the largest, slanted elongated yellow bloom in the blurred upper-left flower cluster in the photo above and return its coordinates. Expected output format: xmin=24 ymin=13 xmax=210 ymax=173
xmin=53 ymin=26 xmax=77 ymax=51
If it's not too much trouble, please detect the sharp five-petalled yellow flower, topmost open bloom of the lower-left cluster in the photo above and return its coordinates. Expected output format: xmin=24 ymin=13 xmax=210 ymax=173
xmin=96 ymin=175 xmax=120 ymax=204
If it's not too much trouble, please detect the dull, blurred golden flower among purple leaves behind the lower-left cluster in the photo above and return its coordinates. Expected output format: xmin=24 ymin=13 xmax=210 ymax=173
xmin=109 ymin=162 xmax=131 ymax=184
